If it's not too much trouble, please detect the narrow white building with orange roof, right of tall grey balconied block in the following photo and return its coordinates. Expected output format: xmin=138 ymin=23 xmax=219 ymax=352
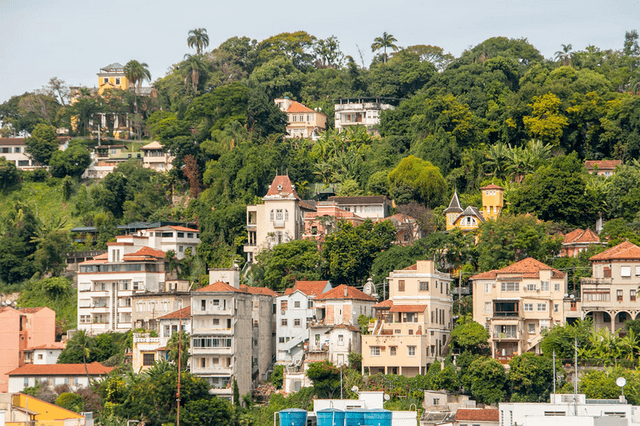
xmin=276 ymin=281 xmax=331 ymax=364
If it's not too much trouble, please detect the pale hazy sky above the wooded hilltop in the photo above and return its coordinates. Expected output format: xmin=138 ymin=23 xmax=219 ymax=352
xmin=0 ymin=0 xmax=640 ymax=103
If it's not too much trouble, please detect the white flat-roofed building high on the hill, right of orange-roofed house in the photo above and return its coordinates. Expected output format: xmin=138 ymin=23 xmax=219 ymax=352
xmin=334 ymin=97 xmax=396 ymax=133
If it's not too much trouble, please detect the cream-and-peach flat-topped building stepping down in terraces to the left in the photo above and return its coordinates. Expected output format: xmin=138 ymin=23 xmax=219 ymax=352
xmin=362 ymin=260 xmax=453 ymax=377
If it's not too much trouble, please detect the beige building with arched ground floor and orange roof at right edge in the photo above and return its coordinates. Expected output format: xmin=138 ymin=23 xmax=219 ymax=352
xmin=580 ymin=241 xmax=640 ymax=332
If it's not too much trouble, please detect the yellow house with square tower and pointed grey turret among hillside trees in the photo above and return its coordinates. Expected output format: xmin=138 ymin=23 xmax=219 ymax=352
xmin=444 ymin=184 xmax=504 ymax=231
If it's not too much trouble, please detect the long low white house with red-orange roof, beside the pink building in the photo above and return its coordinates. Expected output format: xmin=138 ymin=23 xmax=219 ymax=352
xmin=7 ymin=362 xmax=113 ymax=393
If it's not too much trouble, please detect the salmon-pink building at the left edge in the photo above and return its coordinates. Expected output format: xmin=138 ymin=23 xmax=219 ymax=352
xmin=0 ymin=306 xmax=56 ymax=393
